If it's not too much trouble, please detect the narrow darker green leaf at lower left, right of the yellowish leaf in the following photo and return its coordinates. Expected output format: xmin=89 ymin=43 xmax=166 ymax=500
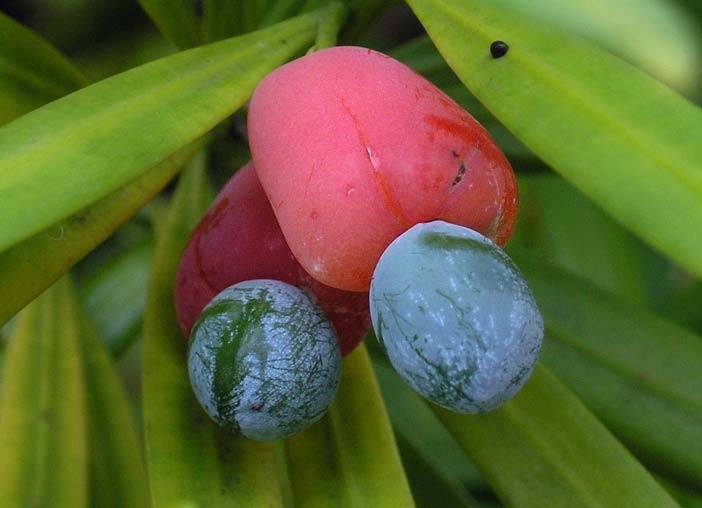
xmin=72 ymin=288 xmax=150 ymax=508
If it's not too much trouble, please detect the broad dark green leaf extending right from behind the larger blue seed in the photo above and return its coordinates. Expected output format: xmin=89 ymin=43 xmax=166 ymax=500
xmin=514 ymin=255 xmax=702 ymax=485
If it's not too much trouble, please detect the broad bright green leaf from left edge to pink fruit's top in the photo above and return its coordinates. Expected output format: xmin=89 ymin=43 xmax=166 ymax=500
xmin=0 ymin=13 xmax=317 ymax=254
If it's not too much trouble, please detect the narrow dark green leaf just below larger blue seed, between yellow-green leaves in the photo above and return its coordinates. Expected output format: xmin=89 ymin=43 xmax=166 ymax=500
xmin=370 ymin=360 xmax=485 ymax=506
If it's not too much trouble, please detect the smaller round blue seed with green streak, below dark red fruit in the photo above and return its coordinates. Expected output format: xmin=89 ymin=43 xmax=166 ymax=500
xmin=188 ymin=280 xmax=341 ymax=440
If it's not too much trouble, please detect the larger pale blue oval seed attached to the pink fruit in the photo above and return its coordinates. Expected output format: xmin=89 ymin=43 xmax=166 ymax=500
xmin=370 ymin=221 xmax=543 ymax=413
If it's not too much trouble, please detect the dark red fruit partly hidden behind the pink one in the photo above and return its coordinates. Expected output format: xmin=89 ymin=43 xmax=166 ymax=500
xmin=175 ymin=163 xmax=370 ymax=355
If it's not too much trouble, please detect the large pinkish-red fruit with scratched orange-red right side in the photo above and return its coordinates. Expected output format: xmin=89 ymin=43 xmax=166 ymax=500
xmin=248 ymin=47 xmax=517 ymax=291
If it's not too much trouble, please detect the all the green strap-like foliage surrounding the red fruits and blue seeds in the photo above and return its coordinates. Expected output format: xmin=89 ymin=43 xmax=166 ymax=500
xmin=0 ymin=0 xmax=702 ymax=508
